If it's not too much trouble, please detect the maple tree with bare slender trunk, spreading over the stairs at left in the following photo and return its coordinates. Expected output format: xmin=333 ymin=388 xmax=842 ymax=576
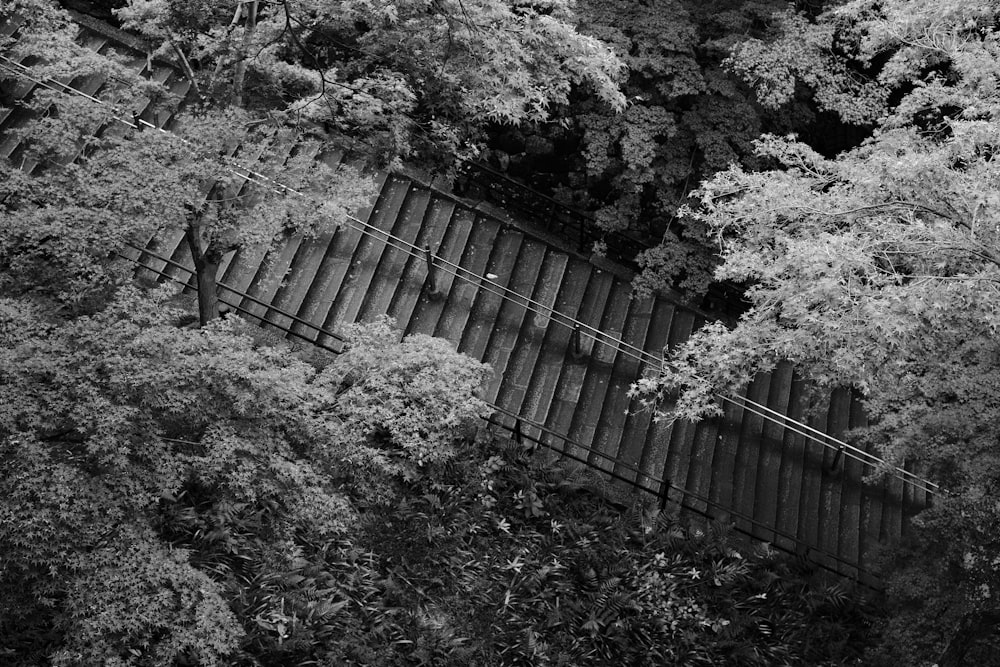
xmin=0 ymin=0 xmax=371 ymax=324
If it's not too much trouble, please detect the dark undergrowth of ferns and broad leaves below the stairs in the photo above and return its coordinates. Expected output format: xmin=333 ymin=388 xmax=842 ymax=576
xmin=367 ymin=445 xmax=870 ymax=665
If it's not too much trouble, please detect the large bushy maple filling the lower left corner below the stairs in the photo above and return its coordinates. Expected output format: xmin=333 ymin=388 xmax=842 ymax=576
xmin=0 ymin=289 xmax=485 ymax=665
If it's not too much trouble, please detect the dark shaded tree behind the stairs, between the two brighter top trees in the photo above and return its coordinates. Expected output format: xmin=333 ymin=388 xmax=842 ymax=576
xmin=484 ymin=0 xmax=817 ymax=293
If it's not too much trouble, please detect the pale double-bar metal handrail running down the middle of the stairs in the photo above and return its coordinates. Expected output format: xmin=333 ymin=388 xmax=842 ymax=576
xmin=0 ymin=44 xmax=938 ymax=493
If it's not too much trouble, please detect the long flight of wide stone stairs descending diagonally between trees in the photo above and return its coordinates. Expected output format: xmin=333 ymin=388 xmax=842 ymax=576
xmin=0 ymin=11 xmax=928 ymax=578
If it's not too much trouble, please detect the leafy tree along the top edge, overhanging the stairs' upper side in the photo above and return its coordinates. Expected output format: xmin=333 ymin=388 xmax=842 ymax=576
xmin=118 ymin=0 xmax=625 ymax=166
